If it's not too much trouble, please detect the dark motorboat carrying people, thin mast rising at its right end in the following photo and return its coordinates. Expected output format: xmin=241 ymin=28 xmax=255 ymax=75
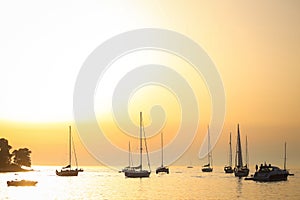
xmin=252 ymin=143 xmax=290 ymax=182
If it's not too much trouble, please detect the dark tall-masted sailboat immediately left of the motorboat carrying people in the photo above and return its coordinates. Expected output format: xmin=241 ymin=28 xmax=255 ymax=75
xmin=234 ymin=124 xmax=249 ymax=177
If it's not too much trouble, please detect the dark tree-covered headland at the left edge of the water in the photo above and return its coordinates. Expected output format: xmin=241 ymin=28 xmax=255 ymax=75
xmin=0 ymin=138 xmax=32 ymax=172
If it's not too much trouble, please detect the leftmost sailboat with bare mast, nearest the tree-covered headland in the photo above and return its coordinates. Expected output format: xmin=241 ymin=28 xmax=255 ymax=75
xmin=56 ymin=126 xmax=83 ymax=176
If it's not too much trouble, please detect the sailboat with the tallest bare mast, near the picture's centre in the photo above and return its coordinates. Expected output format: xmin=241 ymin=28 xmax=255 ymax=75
xmin=125 ymin=112 xmax=151 ymax=178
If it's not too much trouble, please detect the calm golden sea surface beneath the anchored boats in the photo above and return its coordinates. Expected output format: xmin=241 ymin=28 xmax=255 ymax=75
xmin=0 ymin=166 xmax=300 ymax=200
